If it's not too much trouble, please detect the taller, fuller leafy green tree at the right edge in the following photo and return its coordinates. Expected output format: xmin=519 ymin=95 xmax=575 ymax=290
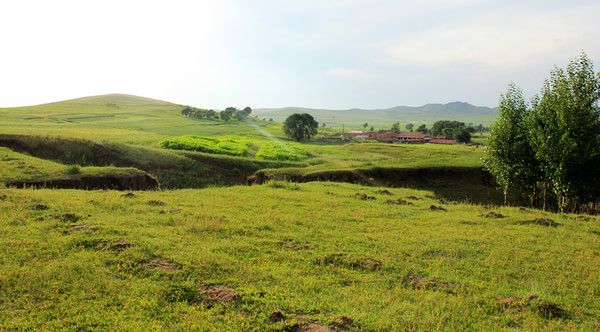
xmin=530 ymin=53 xmax=600 ymax=211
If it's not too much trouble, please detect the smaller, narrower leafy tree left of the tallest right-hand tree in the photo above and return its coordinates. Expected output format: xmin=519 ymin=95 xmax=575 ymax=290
xmin=484 ymin=84 xmax=537 ymax=205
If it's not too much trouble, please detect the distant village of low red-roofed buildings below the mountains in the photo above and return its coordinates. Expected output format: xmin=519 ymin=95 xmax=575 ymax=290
xmin=344 ymin=130 xmax=458 ymax=144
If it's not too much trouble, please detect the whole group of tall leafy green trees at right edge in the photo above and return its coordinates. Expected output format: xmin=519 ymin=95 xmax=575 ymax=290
xmin=484 ymin=53 xmax=600 ymax=212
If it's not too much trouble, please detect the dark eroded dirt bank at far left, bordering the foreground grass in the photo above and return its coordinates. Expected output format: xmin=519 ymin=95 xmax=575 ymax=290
xmin=6 ymin=174 xmax=159 ymax=190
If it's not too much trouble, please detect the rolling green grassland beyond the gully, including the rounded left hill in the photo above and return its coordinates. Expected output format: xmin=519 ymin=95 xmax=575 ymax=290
xmin=0 ymin=95 xmax=482 ymax=188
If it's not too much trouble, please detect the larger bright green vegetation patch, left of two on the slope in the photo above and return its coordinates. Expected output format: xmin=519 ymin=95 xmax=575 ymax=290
xmin=160 ymin=136 xmax=250 ymax=156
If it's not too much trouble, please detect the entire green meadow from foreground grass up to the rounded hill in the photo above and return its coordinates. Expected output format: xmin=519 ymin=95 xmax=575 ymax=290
xmin=0 ymin=95 xmax=600 ymax=331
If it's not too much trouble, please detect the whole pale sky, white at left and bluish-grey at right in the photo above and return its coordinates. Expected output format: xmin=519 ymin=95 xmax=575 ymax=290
xmin=0 ymin=0 xmax=600 ymax=109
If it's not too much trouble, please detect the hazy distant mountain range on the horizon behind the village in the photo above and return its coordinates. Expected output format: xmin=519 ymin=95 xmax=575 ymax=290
xmin=254 ymin=102 xmax=498 ymax=128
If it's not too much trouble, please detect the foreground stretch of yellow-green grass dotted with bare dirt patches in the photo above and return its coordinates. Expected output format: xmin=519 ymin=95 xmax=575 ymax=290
xmin=0 ymin=182 xmax=600 ymax=331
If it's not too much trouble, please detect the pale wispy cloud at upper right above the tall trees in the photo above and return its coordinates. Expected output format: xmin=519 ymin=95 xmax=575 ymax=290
xmin=384 ymin=4 xmax=600 ymax=67
